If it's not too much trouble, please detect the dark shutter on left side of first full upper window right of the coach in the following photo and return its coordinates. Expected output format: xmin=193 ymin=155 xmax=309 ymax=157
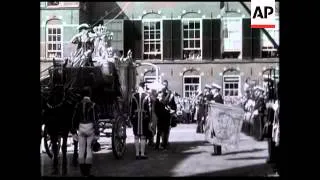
xmin=132 ymin=20 xmax=143 ymax=59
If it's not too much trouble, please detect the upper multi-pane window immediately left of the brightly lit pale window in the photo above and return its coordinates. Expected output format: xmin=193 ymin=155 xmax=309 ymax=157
xmin=182 ymin=19 xmax=202 ymax=59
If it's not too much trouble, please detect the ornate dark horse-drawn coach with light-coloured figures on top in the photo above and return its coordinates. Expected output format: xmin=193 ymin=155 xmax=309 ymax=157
xmin=40 ymin=21 xmax=136 ymax=159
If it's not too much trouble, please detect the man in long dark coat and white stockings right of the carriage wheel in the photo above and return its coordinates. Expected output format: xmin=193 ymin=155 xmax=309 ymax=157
xmin=130 ymin=82 xmax=150 ymax=160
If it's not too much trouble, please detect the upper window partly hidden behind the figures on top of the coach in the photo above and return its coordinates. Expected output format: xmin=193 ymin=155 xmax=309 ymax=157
xmin=106 ymin=19 xmax=123 ymax=55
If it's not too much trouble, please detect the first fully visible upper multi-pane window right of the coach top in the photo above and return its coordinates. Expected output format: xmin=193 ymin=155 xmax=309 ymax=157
xmin=143 ymin=20 xmax=162 ymax=59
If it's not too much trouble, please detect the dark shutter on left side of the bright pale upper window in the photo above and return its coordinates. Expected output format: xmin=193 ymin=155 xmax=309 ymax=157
xmin=212 ymin=19 xmax=223 ymax=59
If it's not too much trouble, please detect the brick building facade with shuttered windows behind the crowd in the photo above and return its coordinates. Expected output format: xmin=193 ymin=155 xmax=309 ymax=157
xmin=40 ymin=2 xmax=279 ymax=101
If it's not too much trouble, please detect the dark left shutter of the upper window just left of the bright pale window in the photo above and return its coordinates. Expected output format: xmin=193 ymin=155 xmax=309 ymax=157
xmin=172 ymin=19 xmax=182 ymax=60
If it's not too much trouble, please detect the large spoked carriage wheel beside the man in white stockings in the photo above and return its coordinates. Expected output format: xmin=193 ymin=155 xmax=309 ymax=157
xmin=112 ymin=115 xmax=127 ymax=159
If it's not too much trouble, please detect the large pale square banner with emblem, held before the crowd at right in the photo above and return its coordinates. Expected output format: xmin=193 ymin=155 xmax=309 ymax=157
xmin=205 ymin=103 xmax=244 ymax=149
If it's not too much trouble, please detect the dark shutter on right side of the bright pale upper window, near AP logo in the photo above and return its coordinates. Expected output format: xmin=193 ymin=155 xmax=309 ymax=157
xmin=242 ymin=18 xmax=253 ymax=59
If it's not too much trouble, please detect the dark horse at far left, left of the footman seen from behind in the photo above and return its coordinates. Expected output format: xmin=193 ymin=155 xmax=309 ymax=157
xmin=43 ymin=86 xmax=78 ymax=174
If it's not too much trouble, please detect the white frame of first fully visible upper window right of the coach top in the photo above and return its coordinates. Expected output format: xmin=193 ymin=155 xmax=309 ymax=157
xmin=142 ymin=18 xmax=163 ymax=60
